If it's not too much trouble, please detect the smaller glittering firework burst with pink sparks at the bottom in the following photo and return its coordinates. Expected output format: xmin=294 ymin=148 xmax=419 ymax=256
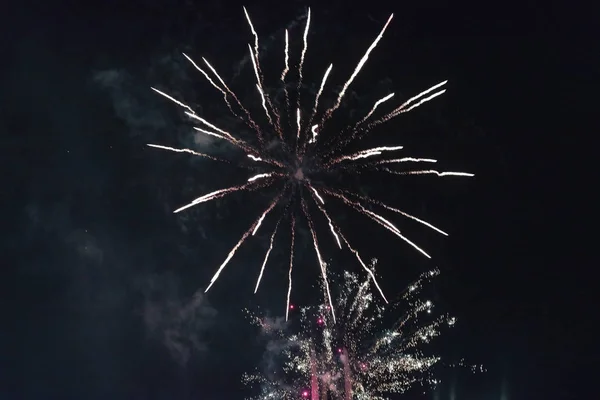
xmin=243 ymin=269 xmax=456 ymax=400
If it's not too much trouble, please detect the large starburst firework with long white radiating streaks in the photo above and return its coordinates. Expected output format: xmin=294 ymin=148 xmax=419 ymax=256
xmin=148 ymin=8 xmax=473 ymax=312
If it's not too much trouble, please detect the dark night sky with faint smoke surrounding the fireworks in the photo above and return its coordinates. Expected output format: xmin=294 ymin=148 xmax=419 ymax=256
xmin=0 ymin=0 xmax=597 ymax=400
